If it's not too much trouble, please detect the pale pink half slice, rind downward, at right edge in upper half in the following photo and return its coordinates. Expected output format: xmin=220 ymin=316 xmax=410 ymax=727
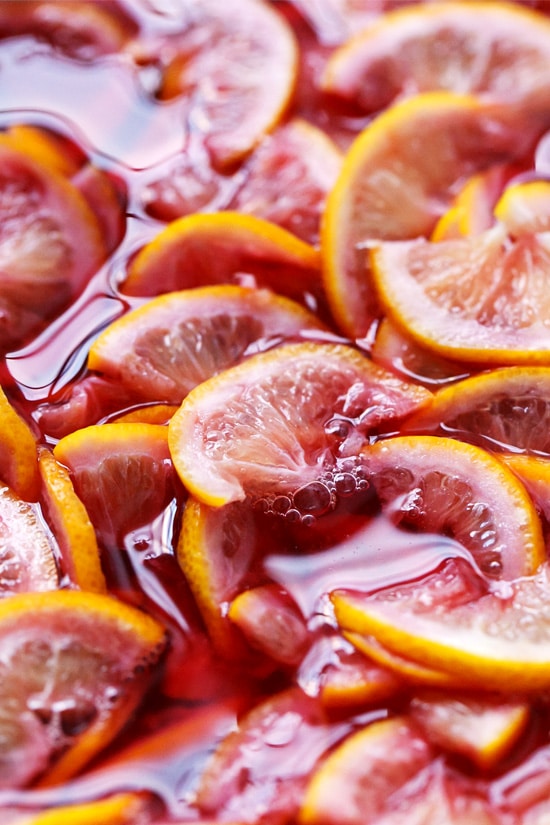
xmin=370 ymin=224 xmax=550 ymax=364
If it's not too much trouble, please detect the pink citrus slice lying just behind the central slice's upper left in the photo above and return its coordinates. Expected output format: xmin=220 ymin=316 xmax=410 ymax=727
xmin=88 ymin=284 xmax=324 ymax=404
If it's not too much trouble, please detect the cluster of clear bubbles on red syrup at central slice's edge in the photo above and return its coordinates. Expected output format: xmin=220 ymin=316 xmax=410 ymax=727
xmin=255 ymin=456 xmax=369 ymax=526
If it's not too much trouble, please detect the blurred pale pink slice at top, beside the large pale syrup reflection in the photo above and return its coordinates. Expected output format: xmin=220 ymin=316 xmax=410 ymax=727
xmin=150 ymin=0 xmax=298 ymax=166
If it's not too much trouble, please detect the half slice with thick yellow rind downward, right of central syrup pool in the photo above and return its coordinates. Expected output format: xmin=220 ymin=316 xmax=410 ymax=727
xmin=331 ymin=560 xmax=550 ymax=694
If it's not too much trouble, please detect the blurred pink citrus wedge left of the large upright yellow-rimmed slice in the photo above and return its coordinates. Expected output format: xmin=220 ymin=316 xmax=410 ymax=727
xmin=232 ymin=118 xmax=342 ymax=244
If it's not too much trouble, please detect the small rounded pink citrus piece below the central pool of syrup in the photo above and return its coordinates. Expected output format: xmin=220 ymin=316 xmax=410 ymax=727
xmin=227 ymin=584 xmax=310 ymax=665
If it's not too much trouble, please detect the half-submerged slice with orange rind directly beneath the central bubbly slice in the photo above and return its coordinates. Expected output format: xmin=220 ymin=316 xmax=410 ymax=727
xmin=176 ymin=497 xmax=257 ymax=658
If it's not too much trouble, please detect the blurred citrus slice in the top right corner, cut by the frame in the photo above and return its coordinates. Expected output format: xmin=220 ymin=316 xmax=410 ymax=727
xmin=322 ymin=2 xmax=550 ymax=112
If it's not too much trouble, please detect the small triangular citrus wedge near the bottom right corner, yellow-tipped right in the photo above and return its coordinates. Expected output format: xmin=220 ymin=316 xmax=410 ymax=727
xmin=410 ymin=692 xmax=530 ymax=771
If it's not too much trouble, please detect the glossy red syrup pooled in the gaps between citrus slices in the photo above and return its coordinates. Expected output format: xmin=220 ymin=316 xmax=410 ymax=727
xmin=0 ymin=0 xmax=548 ymax=821
